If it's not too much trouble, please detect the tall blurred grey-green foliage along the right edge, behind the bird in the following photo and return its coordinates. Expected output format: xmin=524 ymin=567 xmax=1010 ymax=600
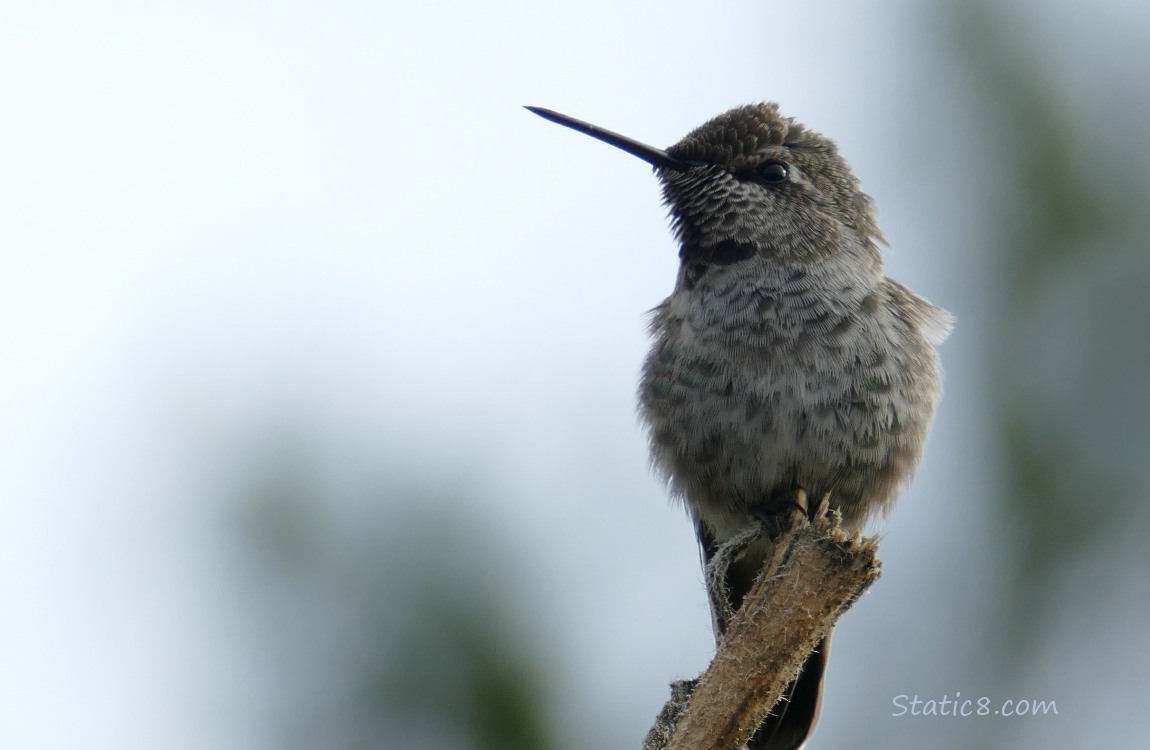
xmin=943 ymin=0 xmax=1150 ymax=674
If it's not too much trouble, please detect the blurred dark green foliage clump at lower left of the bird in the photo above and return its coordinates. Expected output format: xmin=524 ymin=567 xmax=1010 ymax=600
xmin=232 ymin=439 xmax=554 ymax=750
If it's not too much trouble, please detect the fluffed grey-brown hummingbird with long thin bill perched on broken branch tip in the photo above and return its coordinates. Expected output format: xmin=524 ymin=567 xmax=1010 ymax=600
xmin=528 ymin=102 xmax=952 ymax=750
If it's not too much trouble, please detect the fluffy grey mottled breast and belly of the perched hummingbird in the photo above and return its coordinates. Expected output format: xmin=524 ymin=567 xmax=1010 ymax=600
xmin=639 ymin=267 xmax=937 ymax=536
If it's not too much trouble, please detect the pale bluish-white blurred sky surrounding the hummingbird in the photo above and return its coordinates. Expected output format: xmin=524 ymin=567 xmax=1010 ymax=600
xmin=0 ymin=0 xmax=1150 ymax=750
